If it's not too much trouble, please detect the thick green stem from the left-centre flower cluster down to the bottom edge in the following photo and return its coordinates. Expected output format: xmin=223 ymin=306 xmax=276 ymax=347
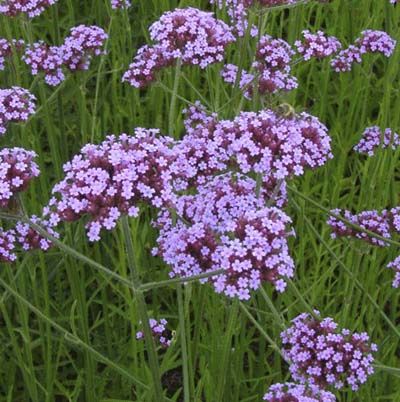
xmin=122 ymin=216 xmax=165 ymax=402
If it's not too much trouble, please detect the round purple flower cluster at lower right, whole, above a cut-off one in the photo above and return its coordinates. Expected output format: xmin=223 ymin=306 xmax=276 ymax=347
xmin=281 ymin=313 xmax=377 ymax=391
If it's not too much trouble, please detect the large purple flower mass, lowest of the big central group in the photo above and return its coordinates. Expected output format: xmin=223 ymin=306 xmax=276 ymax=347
xmin=154 ymin=175 xmax=294 ymax=300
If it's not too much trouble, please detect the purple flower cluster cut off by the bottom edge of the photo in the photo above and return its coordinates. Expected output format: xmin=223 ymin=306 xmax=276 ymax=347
xmin=263 ymin=382 xmax=336 ymax=402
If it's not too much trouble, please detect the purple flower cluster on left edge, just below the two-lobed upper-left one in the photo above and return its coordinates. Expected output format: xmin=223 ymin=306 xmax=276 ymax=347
xmin=0 ymin=87 xmax=36 ymax=136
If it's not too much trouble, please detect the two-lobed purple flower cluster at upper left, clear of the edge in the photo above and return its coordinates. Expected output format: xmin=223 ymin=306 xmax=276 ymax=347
xmin=23 ymin=25 xmax=107 ymax=86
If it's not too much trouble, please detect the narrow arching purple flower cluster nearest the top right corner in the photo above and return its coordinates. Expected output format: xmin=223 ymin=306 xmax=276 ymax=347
xmin=331 ymin=29 xmax=396 ymax=72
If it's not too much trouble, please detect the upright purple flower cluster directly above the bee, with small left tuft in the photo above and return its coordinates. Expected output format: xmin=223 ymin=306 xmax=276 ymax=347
xmin=221 ymin=35 xmax=297 ymax=99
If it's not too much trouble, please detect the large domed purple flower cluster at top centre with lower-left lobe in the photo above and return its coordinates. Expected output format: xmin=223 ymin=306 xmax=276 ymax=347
xmin=122 ymin=8 xmax=235 ymax=88
